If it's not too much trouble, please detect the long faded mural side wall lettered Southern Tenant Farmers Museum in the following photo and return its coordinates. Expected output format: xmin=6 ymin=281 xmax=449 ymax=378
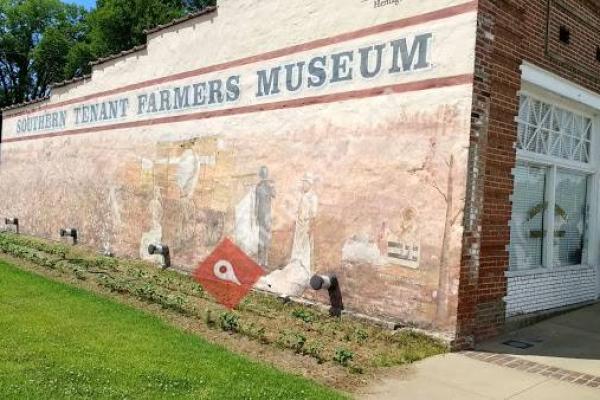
xmin=0 ymin=0 xmax=476 ymax=330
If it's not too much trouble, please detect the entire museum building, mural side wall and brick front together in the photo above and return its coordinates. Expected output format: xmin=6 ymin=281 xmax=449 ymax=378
xmin=0 ymin=0 xmax=600 ymax=346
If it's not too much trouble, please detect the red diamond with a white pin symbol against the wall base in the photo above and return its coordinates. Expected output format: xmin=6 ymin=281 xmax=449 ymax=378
xmin=194 ymin=239 xmax=264 ymax=309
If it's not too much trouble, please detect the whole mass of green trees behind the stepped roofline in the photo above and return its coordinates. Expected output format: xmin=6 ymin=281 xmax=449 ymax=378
xmin=0 ymin=0 xmax=216 ymax=107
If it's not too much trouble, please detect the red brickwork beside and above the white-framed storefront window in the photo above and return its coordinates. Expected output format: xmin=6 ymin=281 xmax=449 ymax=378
xmin=455 ymin=0 xmax=600 ymax=348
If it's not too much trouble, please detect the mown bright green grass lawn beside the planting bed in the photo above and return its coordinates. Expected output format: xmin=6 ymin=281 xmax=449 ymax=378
xmin=0 ymin=262 xmax=344 ymax=400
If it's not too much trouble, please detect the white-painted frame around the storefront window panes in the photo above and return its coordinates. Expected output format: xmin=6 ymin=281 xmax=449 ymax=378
xmin=506 ymin=74 xmax=600 ymax=277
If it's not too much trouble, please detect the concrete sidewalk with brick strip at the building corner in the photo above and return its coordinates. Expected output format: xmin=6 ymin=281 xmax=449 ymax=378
xmin=357 ymin=304 xmax=600 ymax=400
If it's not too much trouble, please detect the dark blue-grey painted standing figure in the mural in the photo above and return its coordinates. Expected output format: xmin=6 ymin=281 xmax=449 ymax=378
xmin=255 ymin=167 xmax=275 ymax=267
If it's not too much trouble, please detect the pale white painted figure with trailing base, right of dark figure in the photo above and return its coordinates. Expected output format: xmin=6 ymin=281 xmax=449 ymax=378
xmin=257 ymin=174 xmax=318 ymax=296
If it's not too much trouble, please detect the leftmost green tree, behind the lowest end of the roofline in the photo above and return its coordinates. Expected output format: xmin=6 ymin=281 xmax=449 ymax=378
xmin=0 ymin=0 xmax=86 ymax=106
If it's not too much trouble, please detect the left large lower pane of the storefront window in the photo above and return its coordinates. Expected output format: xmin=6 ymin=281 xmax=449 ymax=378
xmin=509 ymin=163 xmax=546 ymax=270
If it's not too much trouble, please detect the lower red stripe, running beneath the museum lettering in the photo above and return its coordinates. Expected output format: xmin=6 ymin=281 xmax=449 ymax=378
xmin=3 ymin=74 xmax=473 ymax=143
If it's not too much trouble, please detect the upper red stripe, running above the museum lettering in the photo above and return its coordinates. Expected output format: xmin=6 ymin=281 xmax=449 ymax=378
xmin=2 ymin=0 xmax=477 ymax=118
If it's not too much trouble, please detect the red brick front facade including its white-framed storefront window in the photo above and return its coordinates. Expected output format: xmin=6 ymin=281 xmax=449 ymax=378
xmin=459 ymin=0 xmax=600 ymax=346
